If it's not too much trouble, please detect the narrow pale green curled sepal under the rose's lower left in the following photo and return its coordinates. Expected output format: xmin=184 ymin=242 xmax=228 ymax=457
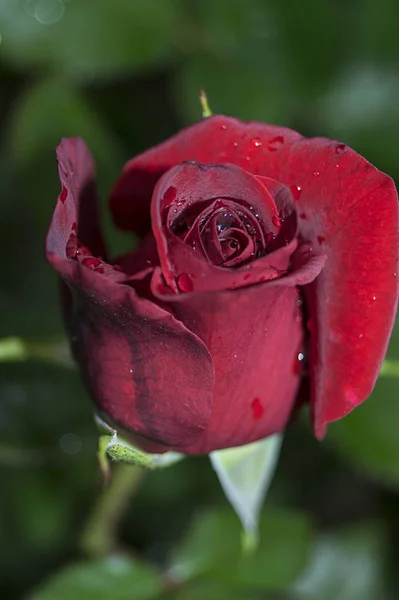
xmin=95 ymin=415 xmax=184 ymax=480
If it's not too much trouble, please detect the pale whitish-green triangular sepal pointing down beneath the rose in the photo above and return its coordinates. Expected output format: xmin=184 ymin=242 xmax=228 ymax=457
xmin=209 ymin=435 xmax=282 ymax=541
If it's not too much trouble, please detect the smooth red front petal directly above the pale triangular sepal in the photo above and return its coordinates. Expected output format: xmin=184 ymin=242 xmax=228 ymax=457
xmin=156 ymin=282 xmax=302 ymax=454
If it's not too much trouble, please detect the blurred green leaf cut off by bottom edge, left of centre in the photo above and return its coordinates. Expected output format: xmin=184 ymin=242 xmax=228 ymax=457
xmin=28 ymin=556 xmax=162 ymax=600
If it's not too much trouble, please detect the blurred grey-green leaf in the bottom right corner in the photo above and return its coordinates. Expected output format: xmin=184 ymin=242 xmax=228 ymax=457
xmin=292 ymin=522 xmax=386 ymax=600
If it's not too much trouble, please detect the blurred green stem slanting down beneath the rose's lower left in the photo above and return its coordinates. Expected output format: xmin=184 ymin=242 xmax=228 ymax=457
xmin=81 ymin=464 xmax=144 ymax=558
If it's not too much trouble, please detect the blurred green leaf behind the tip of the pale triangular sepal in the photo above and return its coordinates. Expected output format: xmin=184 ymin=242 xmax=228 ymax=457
xmin=168 ymin=510 xmax=311 ymax=590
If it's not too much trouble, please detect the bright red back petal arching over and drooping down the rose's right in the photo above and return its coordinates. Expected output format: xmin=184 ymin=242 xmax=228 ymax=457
xmin=111 ymin=116 xmax=399 ymax=437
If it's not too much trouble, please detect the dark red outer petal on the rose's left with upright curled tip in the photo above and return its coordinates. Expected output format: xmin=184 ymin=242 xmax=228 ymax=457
xmin=46 ymin=141 xmax=214 ymax=451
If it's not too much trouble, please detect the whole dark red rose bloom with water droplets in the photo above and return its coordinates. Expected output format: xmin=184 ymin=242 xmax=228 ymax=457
xmin=47 ymin=116 xmax=398 ymax=453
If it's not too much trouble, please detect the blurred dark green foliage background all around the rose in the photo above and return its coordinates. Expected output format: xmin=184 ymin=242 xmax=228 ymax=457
xmin=0 ymin=0 xmax=399 ymax=600
